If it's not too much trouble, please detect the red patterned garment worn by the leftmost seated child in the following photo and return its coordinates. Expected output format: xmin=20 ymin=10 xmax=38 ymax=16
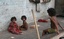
xmin=8 ymin=22 xmax=21 ymax=34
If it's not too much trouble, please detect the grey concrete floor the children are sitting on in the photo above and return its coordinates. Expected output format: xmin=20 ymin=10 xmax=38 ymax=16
xmin=0 ymin=18 xmax=64 ymax=39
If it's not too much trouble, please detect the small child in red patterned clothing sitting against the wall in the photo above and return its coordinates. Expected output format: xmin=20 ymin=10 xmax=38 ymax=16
xmin=8 ymin=17 xmax=22 ymax=34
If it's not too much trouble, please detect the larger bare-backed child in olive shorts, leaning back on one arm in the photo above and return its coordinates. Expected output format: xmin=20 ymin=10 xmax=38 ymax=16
xmin=42 ymin=8 xmax=64 ymax=36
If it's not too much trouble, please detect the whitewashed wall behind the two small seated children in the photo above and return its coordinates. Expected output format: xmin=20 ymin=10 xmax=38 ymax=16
xmin=0 ymin=0 xmax=54 ymax=31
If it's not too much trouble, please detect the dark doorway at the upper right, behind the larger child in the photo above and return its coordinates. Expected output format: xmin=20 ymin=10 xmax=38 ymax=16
xmin=55 ymin=0 xmax=64 ymax=16
